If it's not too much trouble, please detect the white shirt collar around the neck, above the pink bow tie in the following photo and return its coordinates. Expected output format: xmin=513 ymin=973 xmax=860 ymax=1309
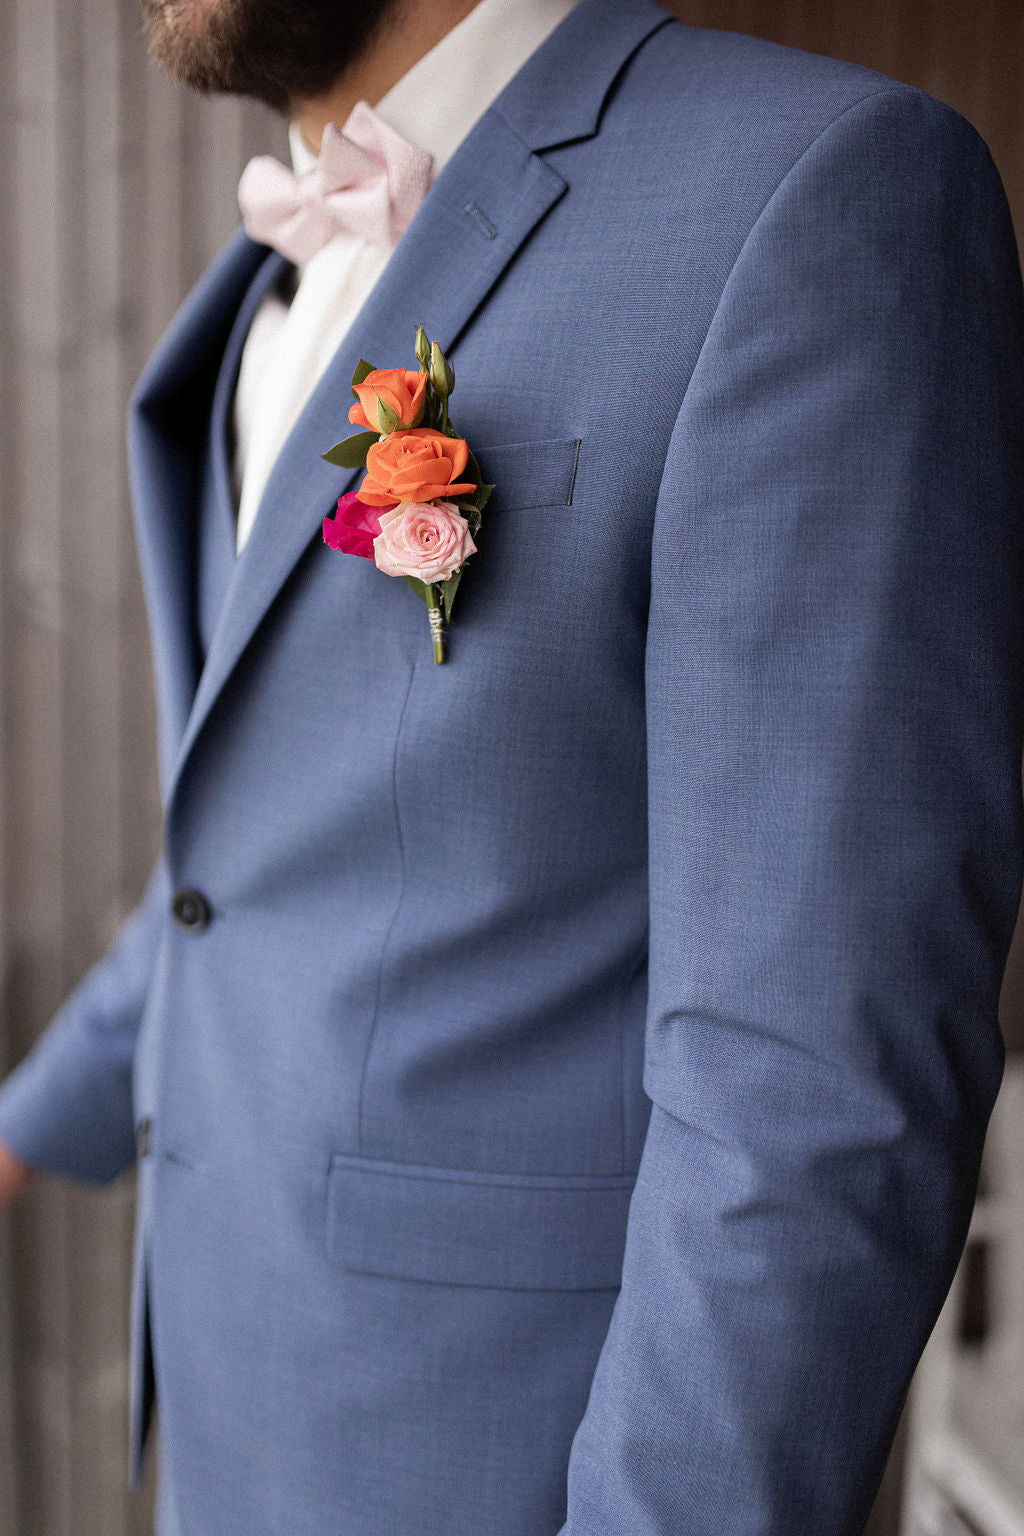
xmin=289 ymin=0 xmax=576 ymax=177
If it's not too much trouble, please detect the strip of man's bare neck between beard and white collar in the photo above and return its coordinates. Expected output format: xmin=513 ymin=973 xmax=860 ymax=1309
xmin=290 ymin=0 xmax=476 ymax=154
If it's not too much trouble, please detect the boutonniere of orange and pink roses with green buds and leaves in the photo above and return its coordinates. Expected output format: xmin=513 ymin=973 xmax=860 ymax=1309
xmin=322 ymin=326 xmax=494 ymax=662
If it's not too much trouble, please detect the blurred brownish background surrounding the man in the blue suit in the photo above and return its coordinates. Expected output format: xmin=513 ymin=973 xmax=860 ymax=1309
xmin=0 ymin=0 xmax=1024 ymax=1536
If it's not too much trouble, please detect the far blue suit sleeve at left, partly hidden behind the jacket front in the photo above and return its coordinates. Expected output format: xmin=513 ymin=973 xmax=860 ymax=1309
xmin=0 ymin=862 xmax=170 ymax=1183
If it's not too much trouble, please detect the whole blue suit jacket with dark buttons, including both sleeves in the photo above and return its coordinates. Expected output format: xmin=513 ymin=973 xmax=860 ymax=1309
xmin=0 ymin=0 xmax=1024 ymax=1536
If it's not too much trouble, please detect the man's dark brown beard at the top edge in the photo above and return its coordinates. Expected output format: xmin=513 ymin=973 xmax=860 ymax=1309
xmin=141 ymin=0 xmax=402 ymax=112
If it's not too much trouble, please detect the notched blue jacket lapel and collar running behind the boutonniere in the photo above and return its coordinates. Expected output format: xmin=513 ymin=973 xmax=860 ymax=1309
xmin=161 ymin=0 xmax=671 ymax=817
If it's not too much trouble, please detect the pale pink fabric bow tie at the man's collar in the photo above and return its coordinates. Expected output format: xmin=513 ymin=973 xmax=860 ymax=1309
xmin=238 ymin=101 xmax=433 ymax=266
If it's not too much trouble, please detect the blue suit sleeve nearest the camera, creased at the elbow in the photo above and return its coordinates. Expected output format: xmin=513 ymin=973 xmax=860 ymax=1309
xmin=563 ymin=88 xmax=1024 ymax=1536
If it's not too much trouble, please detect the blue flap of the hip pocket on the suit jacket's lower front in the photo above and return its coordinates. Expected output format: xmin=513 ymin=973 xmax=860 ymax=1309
xmin=327 ymin=1155 xmax=633 ymax=1290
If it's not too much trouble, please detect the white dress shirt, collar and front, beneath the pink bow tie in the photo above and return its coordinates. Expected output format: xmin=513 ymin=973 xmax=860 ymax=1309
xmin=233 ymin=0 xmax=576 ymax=553
